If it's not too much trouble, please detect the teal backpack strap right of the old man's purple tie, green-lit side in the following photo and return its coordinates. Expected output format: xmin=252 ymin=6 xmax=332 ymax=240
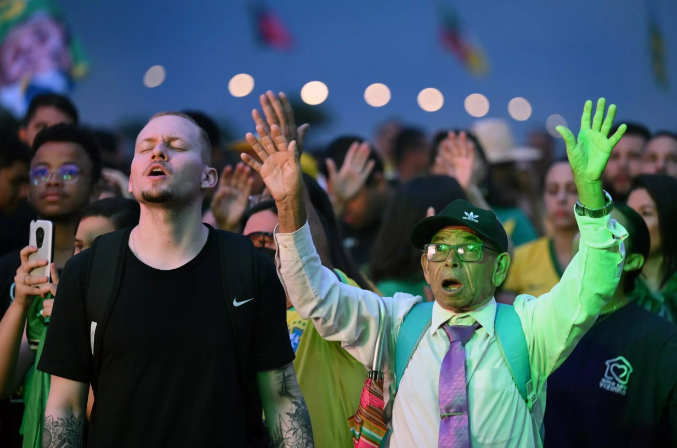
xmin=494 ymin=303 xmax=537 ymax=411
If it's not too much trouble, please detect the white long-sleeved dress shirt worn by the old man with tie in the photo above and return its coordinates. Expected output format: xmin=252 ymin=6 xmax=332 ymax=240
xmin=275 ymin=212 xmax=627 ymax=448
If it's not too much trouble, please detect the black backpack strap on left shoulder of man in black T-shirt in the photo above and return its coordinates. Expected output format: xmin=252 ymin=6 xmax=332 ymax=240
xmin=85 ymin=228 xmax=132 ymax=391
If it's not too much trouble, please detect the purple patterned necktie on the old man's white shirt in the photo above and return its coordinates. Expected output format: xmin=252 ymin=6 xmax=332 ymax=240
xmin=438 ymin=322 xmax=479 ymax=448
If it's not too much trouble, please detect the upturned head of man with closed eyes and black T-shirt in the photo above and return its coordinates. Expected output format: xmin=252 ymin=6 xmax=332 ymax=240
xmin=129 ymin=115 xmax=217 ymax=207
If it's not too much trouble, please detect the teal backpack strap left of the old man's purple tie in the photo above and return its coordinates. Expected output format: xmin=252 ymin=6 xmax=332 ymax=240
xmin=395 ymin=302 xmax=433 ymax=390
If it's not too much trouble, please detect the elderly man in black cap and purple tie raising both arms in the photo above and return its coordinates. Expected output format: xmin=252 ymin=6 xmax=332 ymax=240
xmin=243 ymin=99 xmax=627 ymax=448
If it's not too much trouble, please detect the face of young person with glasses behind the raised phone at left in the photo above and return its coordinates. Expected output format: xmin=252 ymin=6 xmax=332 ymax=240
xmin=30 ymin=142 xmax=93 ymax=221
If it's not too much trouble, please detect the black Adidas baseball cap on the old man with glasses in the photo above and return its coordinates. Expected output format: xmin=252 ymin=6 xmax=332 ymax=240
xmin=410 ymin=199 xmax=508 ymax=252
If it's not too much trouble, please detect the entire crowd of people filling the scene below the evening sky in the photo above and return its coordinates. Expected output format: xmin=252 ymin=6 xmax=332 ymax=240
xmin=0 ymin=92 xmax=677 ymax=448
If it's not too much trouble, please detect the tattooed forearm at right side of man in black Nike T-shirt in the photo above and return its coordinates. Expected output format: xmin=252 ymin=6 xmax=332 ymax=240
xmin=271 ymin=364 xmax=315 ymax=448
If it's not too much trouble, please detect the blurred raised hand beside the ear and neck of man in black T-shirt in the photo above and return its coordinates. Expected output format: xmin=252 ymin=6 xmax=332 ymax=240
xmin=211 ymin=163 xmax=252 ymax=232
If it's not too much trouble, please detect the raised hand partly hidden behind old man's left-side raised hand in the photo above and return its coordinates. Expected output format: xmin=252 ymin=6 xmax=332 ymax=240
xmin=252 ymin=90 xmax=310 ymax=156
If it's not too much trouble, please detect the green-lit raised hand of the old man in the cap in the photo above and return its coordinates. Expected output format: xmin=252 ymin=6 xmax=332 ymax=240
xmin=557 ymin=98 xmax=626 ymax=208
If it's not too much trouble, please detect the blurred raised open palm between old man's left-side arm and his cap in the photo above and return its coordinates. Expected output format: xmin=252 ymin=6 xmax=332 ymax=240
xmin=325 ymin=142 xmax=375 ymax=214
